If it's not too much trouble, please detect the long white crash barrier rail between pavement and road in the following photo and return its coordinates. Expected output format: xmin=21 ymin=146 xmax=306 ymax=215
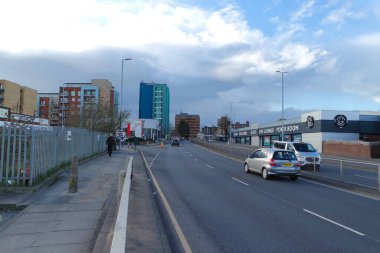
xmin=110 ymin=156 xmax=133 ymax=253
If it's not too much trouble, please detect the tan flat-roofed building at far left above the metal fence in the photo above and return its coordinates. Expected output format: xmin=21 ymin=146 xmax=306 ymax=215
xmin=0 ymin=80 xmax=37 ymax=116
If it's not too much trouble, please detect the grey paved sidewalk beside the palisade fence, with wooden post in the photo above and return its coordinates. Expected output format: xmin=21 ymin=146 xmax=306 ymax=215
xmin=0 ymin=149 xmax=132 ymax=253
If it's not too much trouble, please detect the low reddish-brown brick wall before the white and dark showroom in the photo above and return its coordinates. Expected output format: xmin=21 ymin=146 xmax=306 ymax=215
xmin=322 ymin=141 xmax=380 ymax=158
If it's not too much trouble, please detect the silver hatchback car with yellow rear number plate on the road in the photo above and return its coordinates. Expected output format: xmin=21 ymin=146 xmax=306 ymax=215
xmin=244 ymin=148 xmax=300 ymax=180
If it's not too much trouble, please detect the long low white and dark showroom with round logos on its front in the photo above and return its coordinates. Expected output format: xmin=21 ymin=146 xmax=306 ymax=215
xmin=233 ymin=110 xmax=380 ymax=152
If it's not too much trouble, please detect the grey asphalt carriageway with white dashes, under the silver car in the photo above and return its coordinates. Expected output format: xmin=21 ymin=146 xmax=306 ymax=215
xmin=143 ymin=142 xmax=380 ymax=253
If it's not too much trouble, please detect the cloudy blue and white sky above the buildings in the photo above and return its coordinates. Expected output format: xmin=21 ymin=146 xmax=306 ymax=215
xmin=0 ymin=0 xmax=380 ymax=126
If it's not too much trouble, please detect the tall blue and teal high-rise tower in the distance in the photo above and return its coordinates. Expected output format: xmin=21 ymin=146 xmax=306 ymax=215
xmin=139 ymin=82 xmax=170 ymax=135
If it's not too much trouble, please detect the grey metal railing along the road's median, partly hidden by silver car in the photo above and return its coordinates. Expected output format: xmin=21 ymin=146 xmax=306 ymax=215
xmin=194 ymin=141 xmax=380 ymax=191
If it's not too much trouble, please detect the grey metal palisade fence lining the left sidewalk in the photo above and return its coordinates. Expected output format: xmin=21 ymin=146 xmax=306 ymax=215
xmin=0 ymin=125 xmax=107 ymax=186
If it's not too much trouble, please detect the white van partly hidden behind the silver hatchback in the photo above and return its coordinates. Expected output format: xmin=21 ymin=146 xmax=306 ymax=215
xmin=273 ymin=141 xmax=321 ymax=169
